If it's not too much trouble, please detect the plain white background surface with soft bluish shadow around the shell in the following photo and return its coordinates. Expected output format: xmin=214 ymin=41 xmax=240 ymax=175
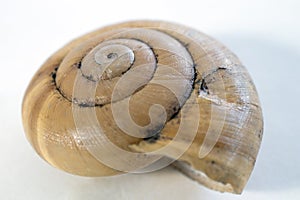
xmin=0 ymin=0 xmax=300 ymax=200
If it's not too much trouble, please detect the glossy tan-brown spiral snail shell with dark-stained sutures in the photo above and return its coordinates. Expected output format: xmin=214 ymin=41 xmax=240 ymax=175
xmin=22 ymin=21 xmax=263 ymax=193
